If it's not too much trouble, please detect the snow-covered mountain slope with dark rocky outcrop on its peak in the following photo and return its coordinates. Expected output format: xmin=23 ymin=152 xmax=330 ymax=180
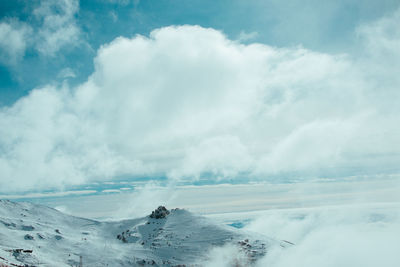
xmin=0 ymin=200 xmax=288 ymax=267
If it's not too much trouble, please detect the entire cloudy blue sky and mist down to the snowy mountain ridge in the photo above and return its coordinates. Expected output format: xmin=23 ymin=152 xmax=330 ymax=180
xmin=0 ymin=0 xmax=400 ymax=267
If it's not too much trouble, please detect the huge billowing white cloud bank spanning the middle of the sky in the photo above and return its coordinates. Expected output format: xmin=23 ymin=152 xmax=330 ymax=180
xmin=0 ymin=8 xmax=400 ymax=192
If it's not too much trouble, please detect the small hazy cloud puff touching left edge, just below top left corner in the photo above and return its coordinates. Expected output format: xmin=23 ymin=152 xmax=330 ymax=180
xmin=0 ymin=20 xmax=32 ymax=66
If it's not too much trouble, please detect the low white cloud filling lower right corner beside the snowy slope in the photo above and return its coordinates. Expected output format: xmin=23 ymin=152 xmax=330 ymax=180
xmin=246 ymin=205 xmax=400 ymax=267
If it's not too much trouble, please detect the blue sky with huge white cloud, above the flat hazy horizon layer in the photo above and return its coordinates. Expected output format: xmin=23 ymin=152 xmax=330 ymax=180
xmin=0 ymin=0 xmax=400 ymax=195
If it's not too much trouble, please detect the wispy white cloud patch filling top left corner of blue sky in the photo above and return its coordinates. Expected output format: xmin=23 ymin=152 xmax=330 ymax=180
xmin=0 ymin=0 xmax=84 ymax=66
